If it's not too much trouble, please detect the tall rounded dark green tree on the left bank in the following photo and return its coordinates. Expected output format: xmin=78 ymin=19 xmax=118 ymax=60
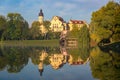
xmin=2 ymin=13 xmax=28 ymax=40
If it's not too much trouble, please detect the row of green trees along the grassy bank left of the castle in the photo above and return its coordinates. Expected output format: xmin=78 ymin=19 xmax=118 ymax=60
xmin=0 ymin=13 xmax=60 ymax=40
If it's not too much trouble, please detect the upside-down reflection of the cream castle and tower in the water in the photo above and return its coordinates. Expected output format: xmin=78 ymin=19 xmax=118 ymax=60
xmin=38 ymin=46 xmax=89 ymax=76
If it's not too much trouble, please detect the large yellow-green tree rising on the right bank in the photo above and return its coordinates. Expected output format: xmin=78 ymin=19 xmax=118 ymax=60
xmin=90 ymin=1 xmax=120 ymax=43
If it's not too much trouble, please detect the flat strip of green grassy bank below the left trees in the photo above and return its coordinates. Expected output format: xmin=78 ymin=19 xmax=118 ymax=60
xmin=0 ymin=40 xmax=59 ymax=46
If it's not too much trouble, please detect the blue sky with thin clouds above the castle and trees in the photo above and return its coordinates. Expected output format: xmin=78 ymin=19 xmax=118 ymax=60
xmin=0 ymin=0 xmax=120 ymax=24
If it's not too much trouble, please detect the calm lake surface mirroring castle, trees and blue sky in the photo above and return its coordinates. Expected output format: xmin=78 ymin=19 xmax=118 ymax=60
xmin=0 ymin=47 xmax=120 ymax=80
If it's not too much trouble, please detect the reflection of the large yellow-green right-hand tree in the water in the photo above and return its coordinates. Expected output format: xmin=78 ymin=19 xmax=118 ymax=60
xmin=90 ymin=47 xmax=120 ymax=80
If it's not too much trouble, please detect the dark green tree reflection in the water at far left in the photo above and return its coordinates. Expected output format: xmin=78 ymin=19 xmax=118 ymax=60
xmin=0 ymin=47 xmax=28 ymax=73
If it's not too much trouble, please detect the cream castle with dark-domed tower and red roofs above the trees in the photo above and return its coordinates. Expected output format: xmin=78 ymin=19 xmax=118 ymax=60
xmin=38 ymin=9 xmax=88 ymax=34
